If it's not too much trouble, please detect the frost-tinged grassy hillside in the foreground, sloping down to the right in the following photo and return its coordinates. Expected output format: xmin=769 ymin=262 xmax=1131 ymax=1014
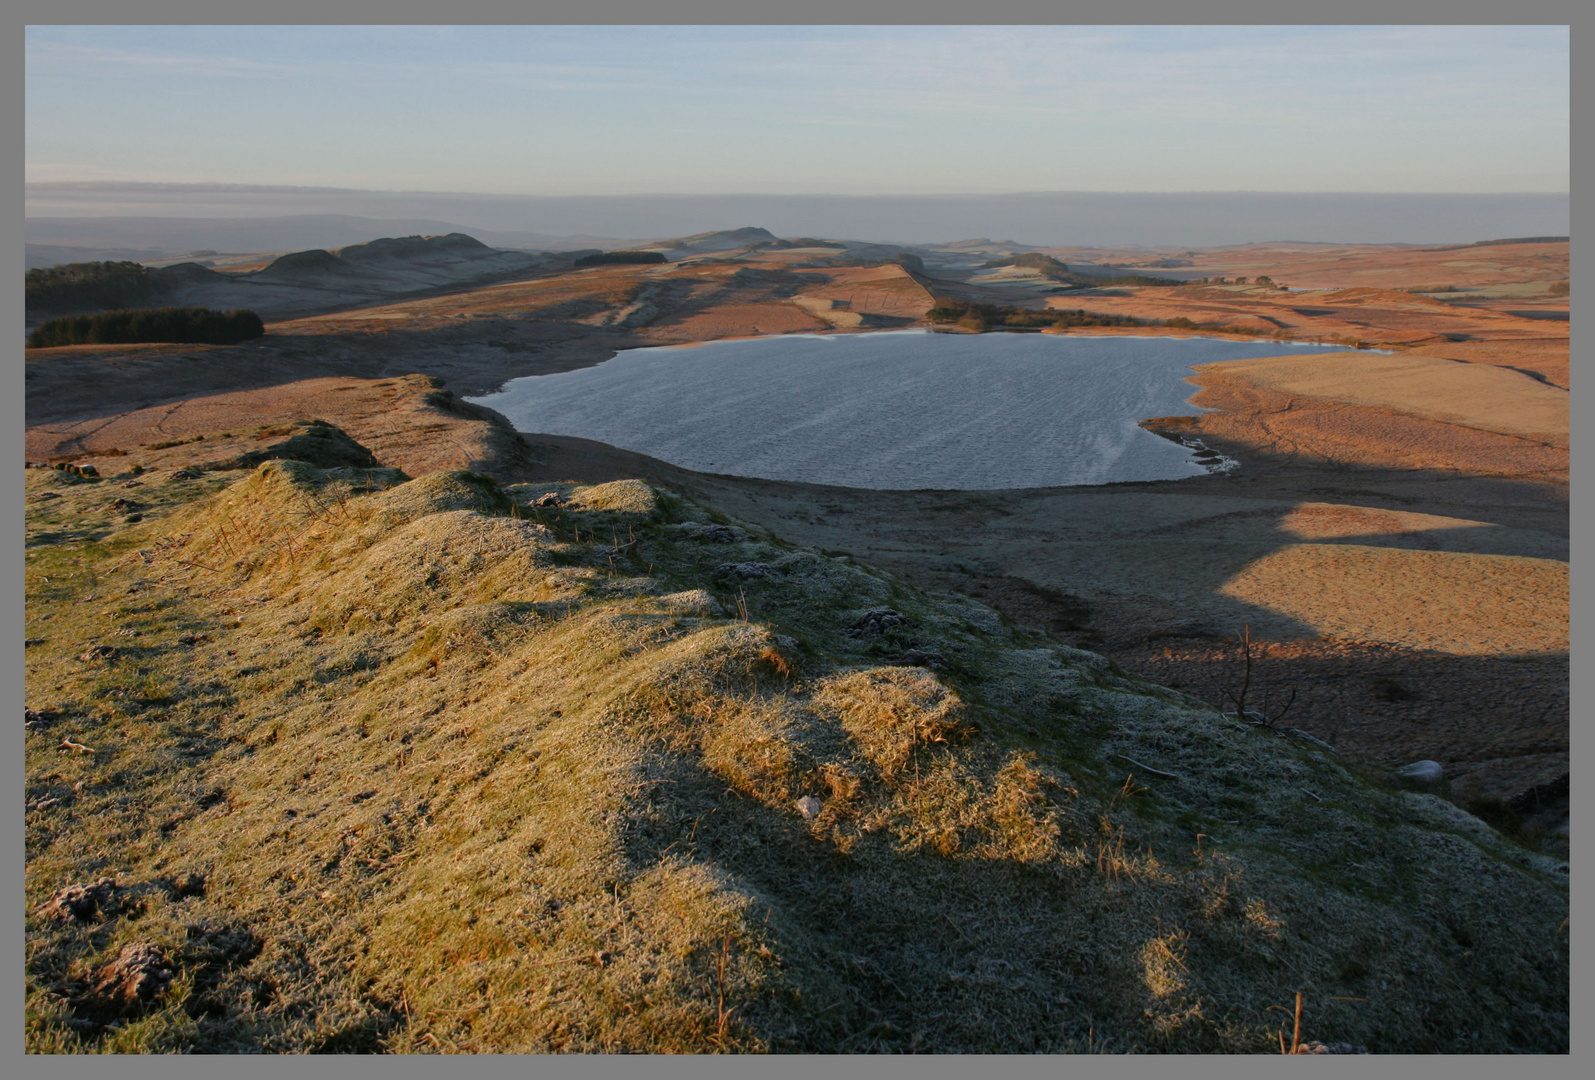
xmin=27 ymin=463 xmax=1568 ymax=1053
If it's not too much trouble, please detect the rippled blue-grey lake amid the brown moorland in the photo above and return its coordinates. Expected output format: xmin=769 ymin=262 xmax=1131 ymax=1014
xmin=472 ymin=330 xmax=1343 ymax=490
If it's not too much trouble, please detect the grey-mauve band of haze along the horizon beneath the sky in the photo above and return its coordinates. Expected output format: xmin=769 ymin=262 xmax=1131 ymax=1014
xmin=27 ymin=182 xmax=1571 ymax=250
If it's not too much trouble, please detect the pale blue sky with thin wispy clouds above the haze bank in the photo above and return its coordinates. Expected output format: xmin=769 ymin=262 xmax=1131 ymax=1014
xmin=26 ymin=26 xmax=1569 ymax=195
